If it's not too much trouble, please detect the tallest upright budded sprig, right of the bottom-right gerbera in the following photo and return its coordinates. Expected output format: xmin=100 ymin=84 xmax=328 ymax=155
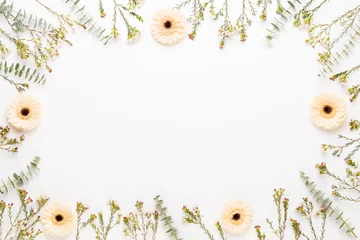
xmin=266 ymin=188 xmax=289 ymax=240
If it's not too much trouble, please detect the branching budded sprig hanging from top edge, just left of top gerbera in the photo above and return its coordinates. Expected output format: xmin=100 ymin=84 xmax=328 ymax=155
xmin=102 ymin=0 xmax=144 ymax=44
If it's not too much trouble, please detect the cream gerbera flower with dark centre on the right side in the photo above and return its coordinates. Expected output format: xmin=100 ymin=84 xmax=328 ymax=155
xmin=310 ymin=93 xmax=346 ymax=129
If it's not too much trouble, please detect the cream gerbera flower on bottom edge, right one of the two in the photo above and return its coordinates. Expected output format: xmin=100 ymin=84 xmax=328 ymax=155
xmin=220 ymin=201 xmax=252 ymax=234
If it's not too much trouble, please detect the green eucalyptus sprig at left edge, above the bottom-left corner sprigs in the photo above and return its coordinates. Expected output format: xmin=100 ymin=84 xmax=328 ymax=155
xmin=0 ymin=157 xmax=40 ymax=194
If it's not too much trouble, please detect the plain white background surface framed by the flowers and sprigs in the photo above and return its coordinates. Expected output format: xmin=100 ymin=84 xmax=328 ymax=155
xmin=0 ymin=0 xmax=360 ymax=240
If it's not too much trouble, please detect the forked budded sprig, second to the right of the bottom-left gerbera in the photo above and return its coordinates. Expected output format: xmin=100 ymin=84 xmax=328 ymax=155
xmin=90 ymin=201 xmax=121 ymax=240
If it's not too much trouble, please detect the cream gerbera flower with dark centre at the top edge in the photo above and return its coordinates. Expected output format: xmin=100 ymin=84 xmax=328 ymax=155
xmin=151 ymin=9 xmax=186 ymax=45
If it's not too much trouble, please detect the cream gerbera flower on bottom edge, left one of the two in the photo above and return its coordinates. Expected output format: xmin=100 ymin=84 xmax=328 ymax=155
xmin=41 ymin=203 xmax=75 ymax=237
